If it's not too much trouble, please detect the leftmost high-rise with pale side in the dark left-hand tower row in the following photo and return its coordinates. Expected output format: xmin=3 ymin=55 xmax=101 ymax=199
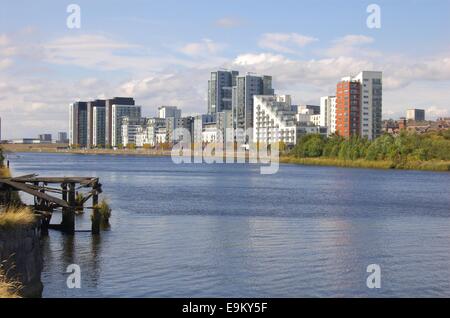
xmin=69 ymin=102 xmax=88 ymax=147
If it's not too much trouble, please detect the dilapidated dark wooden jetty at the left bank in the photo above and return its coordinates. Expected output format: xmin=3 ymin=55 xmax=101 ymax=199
xmin=0 ymin=174 xmax=102 ymax=234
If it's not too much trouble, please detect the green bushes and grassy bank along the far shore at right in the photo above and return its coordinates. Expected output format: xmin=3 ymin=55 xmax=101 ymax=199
xmin=280 ymin=131 xmax=450 ymax=171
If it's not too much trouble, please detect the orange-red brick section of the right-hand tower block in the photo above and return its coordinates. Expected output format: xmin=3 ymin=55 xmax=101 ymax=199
xmin=336 ymin=79 xmax=361 ymax=137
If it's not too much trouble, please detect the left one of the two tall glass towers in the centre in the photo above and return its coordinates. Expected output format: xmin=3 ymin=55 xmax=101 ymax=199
xmin=208 ymin=70 xmax=239 ymax=114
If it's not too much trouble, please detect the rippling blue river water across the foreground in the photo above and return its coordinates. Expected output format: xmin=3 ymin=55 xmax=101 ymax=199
xmin=10 ymin=153 xmax=450 ymax=297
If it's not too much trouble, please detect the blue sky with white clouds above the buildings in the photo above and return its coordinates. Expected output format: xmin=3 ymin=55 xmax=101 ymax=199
xmin=0 ymin=0 xmax=450 ymax=139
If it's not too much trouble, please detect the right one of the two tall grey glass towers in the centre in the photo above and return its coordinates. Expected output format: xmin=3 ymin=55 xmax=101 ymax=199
xmin=232 ymin=74 xmax=274 ymax=131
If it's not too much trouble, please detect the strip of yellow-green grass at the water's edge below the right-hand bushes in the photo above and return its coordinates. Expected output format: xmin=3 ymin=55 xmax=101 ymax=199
xmin=280 ymin=156 xmax=450 ymax=172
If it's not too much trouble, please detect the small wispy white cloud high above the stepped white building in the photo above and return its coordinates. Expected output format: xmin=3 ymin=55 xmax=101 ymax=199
xmin=258 ymin=33 xmax=318 ymax=53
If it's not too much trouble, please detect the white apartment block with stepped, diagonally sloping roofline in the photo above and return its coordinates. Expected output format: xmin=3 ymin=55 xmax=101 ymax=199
xmin=253 ymin=95 xmax=297 ymax=145
